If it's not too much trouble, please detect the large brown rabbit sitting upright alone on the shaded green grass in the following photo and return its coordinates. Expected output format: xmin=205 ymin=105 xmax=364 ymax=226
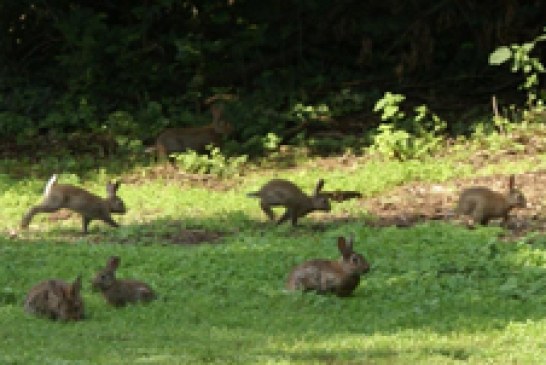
xmin=286 ymin=233 xmax=370 ymax=297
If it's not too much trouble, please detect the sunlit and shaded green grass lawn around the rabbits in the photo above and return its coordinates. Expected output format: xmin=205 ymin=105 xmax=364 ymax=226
xmin=0 ymin=152 xmax=546 ymax=364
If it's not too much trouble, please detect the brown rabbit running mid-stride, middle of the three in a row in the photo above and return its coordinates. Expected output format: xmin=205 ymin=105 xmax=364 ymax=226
xmin=247 ymin=179 xmax=331 ymax=226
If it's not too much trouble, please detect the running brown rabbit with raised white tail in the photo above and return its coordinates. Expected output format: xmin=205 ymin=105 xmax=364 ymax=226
xmin=21 ymin=175 xmax=126 ymax=233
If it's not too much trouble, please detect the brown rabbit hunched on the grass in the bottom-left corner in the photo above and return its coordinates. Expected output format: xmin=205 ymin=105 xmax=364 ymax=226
xmin=24 ymin=276 xmax=84 ymax=321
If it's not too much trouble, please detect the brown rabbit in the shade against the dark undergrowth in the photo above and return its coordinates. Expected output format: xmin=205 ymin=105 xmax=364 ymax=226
xmin=155 ymin=104 xmax=233 ymax=160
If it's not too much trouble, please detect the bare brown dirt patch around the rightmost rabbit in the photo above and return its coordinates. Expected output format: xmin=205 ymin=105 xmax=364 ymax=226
xmin=362 ymin=171 xmax=546 ymax=240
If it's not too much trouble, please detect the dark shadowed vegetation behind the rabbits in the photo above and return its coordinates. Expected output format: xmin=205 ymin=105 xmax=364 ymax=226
xmin=0 ymin=0 xmax=546 ymax=158
